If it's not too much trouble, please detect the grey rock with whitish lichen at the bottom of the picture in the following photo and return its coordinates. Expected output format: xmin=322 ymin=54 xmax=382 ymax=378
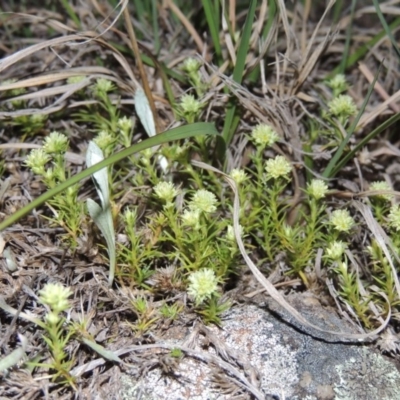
xmin=119 ymin=295 xmax=400 ymax=400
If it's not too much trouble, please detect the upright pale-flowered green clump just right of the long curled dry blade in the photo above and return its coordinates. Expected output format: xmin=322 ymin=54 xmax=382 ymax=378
xmin=238 ymin=124 xmax=328 ymax=285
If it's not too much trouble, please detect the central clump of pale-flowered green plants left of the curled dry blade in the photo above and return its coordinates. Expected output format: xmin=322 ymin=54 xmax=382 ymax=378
xmin=118 ymin=181 xmax=238 ymax=321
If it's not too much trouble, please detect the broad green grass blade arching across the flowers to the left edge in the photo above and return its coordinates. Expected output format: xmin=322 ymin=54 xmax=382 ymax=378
xmin=0 ymin=122 xmax=218 ymax=231
